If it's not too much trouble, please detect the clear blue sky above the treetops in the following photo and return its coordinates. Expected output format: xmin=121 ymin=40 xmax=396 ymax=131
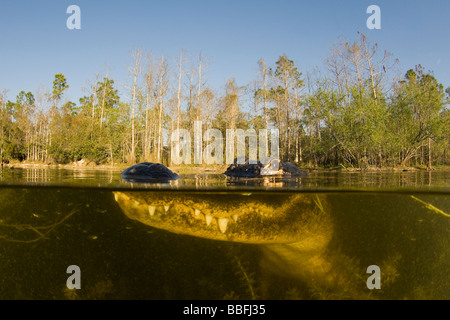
xmin=0 ymin=0 xmax=450 ymax=103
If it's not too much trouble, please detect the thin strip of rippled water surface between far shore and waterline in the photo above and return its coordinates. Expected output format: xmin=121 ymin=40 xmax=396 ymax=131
xmin=0 ymin=167 xmax=450 ymax=191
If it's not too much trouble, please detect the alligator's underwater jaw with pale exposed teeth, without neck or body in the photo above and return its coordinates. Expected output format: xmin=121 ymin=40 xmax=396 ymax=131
xmin=114 ymin=191 xmax=325 ymax=243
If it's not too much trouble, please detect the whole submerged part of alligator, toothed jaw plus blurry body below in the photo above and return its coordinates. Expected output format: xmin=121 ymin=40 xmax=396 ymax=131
xmin=110 ymin=190 xmax=386 ymax=298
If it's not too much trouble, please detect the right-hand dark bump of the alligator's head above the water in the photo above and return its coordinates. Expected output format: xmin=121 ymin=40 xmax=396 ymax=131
xmin=224 ymin=157 xmax=307 ymax=178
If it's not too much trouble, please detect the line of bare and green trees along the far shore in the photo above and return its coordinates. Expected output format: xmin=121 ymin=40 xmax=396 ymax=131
xmin=0 ymin=33 xmax=450 ymax=167
